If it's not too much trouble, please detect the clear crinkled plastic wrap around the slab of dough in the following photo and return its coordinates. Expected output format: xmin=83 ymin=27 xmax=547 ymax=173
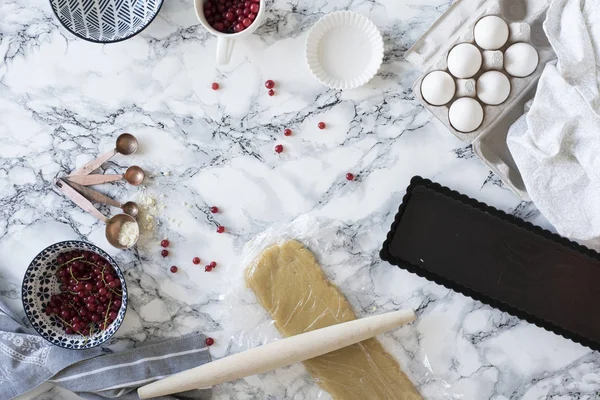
xmin=222 ymin=216 xmax=464 ymax=400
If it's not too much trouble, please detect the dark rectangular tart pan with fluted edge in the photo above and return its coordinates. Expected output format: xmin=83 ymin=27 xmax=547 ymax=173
xmin=380 ymin=176 xmax=600 ymax=350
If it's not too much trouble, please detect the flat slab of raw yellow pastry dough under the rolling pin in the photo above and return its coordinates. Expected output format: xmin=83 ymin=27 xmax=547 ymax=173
xmin=246 ymin=240 xmax=421 ymax=400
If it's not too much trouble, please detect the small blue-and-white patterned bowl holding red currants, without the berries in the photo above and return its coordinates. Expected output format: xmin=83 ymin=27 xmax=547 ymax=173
xmin=21 ymin=240 xmax=127 ymax=350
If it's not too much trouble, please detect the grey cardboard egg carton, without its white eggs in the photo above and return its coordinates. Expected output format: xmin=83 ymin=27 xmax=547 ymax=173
xmin=406 ymin=0 xmax=556 ymax=200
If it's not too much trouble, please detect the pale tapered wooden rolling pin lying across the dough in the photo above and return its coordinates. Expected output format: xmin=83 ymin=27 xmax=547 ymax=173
xmin=138 ymin=310 xmax=415 ymax=399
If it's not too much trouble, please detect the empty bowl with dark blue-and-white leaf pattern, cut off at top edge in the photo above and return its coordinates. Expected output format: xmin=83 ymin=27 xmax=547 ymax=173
xmin=50 ymin=0 xmax=163 ymax=43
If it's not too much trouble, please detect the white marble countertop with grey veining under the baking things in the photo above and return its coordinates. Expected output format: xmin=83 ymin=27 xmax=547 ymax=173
xmin=0 ymin=0 xmax=600 ymax=400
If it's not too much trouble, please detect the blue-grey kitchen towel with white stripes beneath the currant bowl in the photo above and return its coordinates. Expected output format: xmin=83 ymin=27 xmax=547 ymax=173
xmin=0 ymin=299 xmax=211 ymax=400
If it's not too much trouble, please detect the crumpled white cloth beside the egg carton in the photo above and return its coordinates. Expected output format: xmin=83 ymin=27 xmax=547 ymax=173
xmin=507 ymin=0 xmax=600 ymax=240
